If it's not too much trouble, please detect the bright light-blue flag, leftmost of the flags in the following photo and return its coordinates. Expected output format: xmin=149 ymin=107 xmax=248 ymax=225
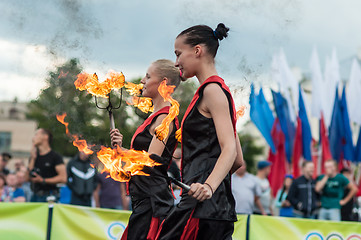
xmin=249 ymin=84 xmax=276 ymax=153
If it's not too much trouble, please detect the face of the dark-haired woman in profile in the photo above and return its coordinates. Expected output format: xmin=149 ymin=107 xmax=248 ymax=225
xmin=174 ymin=36 xmax=199 ymax=78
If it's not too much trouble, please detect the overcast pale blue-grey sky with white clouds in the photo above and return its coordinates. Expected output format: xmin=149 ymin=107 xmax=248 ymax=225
xmin=0 ymin=0 xmax=361 ymax=104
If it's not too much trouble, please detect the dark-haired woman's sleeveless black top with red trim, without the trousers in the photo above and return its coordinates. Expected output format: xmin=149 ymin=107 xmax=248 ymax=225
xmin=181 ymin=76 xmax=237 ymax=221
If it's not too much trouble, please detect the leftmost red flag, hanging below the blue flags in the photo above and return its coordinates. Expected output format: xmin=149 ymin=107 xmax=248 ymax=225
xmin=268 ymin=118 xmax=286 ymax=197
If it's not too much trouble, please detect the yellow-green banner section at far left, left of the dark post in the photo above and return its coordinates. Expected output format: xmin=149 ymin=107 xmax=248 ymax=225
xmin=0 ymin=202 xmax=49 ymax=240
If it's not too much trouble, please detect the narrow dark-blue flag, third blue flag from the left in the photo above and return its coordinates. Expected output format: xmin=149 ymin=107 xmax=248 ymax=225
xmin=298 ymin=86 xmax=312 ymax=161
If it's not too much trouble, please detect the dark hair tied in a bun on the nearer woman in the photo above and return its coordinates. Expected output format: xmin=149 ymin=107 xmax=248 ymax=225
xmin=177 ymin=23 xmax=229 ymax=57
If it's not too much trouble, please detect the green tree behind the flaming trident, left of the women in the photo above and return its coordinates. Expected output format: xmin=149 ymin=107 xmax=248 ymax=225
xmin=27 ymin=59 xmax=137 ymax=156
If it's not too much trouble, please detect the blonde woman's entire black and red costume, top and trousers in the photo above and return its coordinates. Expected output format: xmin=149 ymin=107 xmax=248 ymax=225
xmin=121 ymin=107 xmax=179 ymax=240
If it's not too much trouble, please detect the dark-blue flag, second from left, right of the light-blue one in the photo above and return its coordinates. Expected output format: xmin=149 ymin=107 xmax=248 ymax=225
xmin=272 ymin=91 xmax=296 ymax=162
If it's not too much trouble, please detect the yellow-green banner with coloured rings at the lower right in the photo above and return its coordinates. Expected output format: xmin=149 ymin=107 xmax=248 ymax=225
xmin=249 ymin=215 xmax=361 ymax=240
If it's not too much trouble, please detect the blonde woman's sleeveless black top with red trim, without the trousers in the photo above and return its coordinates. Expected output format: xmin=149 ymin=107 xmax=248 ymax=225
xmin=129 ymin=106 xmax=179 ymax=217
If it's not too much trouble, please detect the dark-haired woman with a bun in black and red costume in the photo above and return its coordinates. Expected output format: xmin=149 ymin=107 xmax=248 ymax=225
xmin=157 ymin=24 xmax=243 ymax=240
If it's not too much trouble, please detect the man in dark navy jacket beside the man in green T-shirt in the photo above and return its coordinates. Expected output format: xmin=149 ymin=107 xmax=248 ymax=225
xmin=286 ymin=161 xmax=319 ymax=219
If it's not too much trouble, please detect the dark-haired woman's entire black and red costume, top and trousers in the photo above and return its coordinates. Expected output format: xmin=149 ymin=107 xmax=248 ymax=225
xmin=157 ymin=76 xmax=237 ymax=240
